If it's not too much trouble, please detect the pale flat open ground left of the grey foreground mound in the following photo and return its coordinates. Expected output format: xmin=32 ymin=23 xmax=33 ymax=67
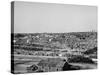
xmin=14 ymin=55 xmax=65 ymax=73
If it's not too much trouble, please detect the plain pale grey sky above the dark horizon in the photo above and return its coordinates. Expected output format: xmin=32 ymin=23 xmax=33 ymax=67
xmin=14 ymin=1 xmax=97 ymax=33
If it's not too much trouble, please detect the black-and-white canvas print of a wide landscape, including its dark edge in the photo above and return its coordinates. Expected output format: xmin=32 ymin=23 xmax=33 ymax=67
xmin=11 ymin=1 xmax=98 ymax=74
